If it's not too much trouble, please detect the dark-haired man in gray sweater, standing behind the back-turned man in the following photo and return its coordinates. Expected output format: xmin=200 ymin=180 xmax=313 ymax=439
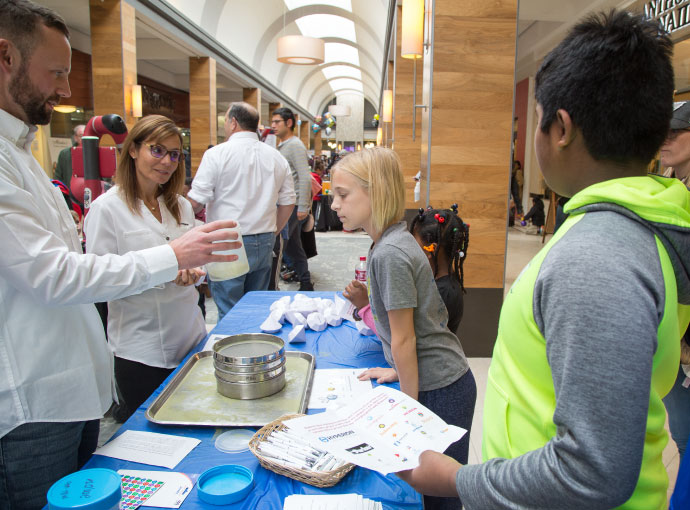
xmin=271 ymin=108 xmax=314 ymax=291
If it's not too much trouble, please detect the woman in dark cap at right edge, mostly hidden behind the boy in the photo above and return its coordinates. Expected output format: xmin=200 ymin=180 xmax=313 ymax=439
xmin=659 ymin=101 xmax=690 ymax=460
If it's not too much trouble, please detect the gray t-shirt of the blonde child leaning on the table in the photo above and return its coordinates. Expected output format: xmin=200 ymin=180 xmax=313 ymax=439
xmin=367 ymin=221 xmax=469 ymax=391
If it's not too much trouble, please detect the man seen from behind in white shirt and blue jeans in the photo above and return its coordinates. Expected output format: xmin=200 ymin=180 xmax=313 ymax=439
xmin=187 ymin=103 xmax=296 ymax=318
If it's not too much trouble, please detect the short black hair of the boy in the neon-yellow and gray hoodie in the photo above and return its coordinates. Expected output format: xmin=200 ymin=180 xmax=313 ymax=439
xmin=536 ymin=10 xmax=674 ymax=164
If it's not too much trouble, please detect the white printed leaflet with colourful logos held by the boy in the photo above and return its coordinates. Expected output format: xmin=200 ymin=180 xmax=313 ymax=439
xmin=282 ymin=386 xmax=467 ymax=475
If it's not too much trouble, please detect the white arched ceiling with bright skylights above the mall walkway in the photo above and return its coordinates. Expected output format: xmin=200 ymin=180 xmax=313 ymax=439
xmin=167 ymin=0 xmax=390 ymax=114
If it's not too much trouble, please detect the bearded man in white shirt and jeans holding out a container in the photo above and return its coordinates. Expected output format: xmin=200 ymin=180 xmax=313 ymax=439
xmin=0 ymin=0 xmax=239 ymax=510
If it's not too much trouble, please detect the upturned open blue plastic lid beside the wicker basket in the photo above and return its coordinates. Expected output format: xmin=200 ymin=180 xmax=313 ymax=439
xmin=196 ymin=464 xmax=254 ymax=505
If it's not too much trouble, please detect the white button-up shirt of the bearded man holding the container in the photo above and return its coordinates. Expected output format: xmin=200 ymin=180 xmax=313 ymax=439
xmin=0 ymin=110 xmax=177 ymax=437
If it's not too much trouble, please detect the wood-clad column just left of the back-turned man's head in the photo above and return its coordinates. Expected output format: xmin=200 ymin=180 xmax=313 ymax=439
xmin=189 ymin=57 xmax=218 ymax=175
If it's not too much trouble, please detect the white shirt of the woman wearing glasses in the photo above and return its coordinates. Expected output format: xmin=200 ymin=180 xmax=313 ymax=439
xmin=84 ymin=187 xmax=206 ymax=368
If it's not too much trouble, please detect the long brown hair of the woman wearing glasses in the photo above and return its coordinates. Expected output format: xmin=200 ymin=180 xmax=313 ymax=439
xmin=115 ymin=115 xmax=185 ymax=225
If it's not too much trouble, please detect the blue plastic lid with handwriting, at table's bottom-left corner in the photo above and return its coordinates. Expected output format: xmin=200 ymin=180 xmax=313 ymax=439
xmin=48 ymin=468 xmax=122 ymax=510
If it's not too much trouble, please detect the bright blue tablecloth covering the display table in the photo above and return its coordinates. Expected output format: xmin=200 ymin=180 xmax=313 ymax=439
xmin=85 ymin=292 xmax=422 ymax=510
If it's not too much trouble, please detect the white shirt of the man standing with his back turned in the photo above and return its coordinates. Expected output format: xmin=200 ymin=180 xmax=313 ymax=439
xmin=188 ymin=131 xmax=296 ymax=235
